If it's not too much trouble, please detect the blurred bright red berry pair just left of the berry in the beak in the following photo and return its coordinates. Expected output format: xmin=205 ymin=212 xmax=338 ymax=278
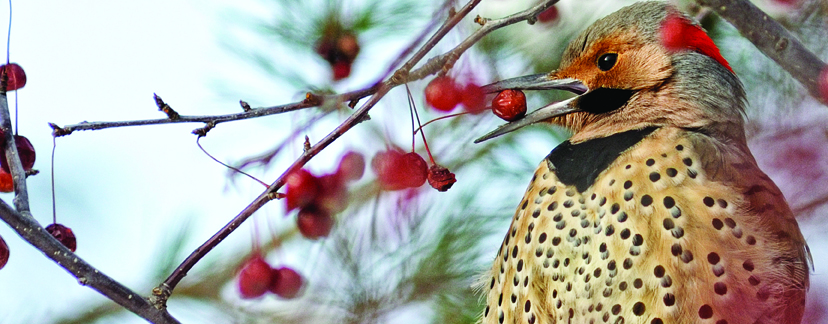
xmin=425 ymin=76 xmax=486 ymax=113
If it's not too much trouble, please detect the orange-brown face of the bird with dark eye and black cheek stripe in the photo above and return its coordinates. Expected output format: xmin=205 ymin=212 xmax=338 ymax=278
xmin=549 ymin=28 xmax=692 ymax=142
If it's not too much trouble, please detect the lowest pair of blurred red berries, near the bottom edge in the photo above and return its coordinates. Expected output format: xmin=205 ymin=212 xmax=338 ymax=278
xmin=238 ymin=255 xmax=303 ymax=299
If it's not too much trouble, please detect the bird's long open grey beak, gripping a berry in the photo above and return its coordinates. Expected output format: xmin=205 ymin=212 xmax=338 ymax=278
xmin=474 ymin=74 xmax=589 ymax=143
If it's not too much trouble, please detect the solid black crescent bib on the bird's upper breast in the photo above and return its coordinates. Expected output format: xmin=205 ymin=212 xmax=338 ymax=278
xmin=546 ymin=127 xmax=656 ymax=192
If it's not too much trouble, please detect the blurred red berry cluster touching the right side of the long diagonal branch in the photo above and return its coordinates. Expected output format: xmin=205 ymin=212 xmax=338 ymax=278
xmin=285 ymin=152 xmax=365 ymax=239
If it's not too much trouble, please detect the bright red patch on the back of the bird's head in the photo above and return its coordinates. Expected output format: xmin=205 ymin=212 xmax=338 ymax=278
xmin=661 ymin=12 xmax=733 ymax=72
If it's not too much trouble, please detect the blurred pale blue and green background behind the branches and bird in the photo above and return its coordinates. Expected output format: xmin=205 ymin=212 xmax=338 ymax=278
xmin=0 ymin=0 xmax=828 ymax=324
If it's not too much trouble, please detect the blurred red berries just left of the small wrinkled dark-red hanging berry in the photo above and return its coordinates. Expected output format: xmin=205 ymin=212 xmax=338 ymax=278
xmin=371 ymin=150 xmax=428 ymax=190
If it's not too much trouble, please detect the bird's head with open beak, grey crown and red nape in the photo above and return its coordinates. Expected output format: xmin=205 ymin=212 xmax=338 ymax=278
xmin=475 ymin=2 xmax=745 ymax=143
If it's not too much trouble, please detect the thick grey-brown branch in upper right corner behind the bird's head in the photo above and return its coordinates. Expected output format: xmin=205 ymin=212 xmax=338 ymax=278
xmin=697 ymin=0 xmax=828 ymax=105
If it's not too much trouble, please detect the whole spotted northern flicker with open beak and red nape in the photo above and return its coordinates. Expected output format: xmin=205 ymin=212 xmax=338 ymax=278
xmin=478 ymin=2 xmax=810 ymax=324
